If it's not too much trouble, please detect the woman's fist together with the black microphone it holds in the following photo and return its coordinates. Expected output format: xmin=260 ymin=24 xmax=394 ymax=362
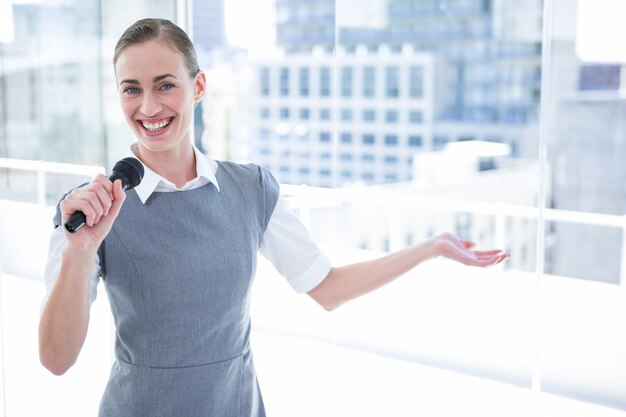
xmin=61 ymin=158 xmax=144 ymax=233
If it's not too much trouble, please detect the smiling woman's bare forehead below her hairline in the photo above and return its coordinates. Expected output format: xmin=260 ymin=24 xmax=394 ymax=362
xmin=115 ymin=40 xmax=185 ymax=82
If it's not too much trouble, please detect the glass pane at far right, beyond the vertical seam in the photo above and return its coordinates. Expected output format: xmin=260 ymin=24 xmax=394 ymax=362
xmin=542 ymin=0 xmax=626 ymax=410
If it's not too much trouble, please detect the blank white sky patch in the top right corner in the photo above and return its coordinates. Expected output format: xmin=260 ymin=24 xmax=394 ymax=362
xmin=576 ymin=0 xmax=626 ymax=63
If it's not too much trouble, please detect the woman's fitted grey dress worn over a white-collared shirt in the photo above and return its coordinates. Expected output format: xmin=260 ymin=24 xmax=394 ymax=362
xmin=99 ymin=162 xmax=279 ymax=417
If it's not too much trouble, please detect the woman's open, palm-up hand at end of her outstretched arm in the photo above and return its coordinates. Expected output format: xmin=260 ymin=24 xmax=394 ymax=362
xmin=435 ymin=233 xmax=511 ymax=267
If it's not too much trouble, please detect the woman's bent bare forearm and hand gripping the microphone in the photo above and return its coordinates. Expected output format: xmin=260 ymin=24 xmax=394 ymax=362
xmin=39 ymin=175 xmax=125 ymax=375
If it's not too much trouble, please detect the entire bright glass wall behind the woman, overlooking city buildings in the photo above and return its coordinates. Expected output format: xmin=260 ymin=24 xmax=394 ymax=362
xmin=0 ymin=0 xmax=626 ymax=416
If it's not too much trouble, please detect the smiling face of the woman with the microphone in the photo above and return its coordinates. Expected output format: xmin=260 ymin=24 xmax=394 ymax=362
xmin=115 ymin=40 xmax=206 ymax=153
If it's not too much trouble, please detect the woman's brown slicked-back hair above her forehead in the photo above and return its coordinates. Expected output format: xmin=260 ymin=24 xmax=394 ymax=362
xmin=113 ymin=18 xmax=200 ymax=78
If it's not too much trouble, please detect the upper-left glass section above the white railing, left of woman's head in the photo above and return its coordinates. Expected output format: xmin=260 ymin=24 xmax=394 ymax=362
xmin=2 ymin=2 xmax=103 ymax=164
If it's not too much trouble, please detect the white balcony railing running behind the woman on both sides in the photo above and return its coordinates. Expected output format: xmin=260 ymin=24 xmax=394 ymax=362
xmin=0 ymin=158 xmax=626 ymax=287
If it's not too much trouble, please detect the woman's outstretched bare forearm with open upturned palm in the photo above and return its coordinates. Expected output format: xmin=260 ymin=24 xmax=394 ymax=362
xmin=307 ymin=233 xmax=509 ymax=310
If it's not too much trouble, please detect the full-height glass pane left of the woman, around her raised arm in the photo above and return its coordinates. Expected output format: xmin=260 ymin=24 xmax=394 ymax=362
xmin=0 ymin=0 xmax=177 ymax=416
